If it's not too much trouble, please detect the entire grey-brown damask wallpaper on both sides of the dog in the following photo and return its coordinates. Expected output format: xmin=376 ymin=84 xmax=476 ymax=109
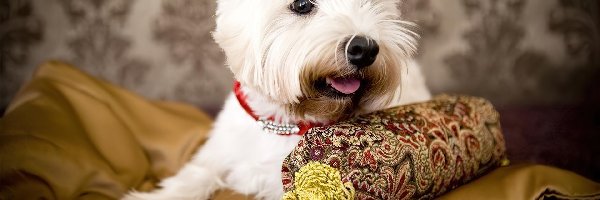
xmin=0 ymin=0 xmax=600 ymax=113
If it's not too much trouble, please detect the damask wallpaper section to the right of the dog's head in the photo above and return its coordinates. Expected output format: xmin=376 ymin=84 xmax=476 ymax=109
xmin=405 ymin=0 xmax=600 ymax=105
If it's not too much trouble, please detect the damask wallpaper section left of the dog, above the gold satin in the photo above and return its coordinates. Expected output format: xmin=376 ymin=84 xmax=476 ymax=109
xmin=0 ymin=0 xmax=232 ymax=113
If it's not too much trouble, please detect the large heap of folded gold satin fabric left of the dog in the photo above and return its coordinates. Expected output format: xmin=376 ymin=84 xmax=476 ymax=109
xmin=0 ymin=62 xmax=212 ymax=199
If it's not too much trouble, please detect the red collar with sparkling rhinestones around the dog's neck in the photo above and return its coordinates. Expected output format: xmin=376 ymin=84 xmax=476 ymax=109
xmin=233 ymin=81 xmax=321 ymax=135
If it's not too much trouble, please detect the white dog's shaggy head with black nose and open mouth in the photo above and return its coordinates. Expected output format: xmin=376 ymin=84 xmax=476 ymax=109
xmin=213 ymin=0 xmax=416 ymax=120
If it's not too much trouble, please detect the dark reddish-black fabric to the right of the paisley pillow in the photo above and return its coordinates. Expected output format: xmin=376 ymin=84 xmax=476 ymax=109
xmin=498 ymin=105 xmax=600 ymax=181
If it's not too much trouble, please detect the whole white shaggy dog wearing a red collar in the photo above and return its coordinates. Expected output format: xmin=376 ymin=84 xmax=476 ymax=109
xmin=125 ymin=0 xmax=430 ymax=199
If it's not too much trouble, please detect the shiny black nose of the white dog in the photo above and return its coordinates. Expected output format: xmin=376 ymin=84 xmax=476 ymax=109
xmin=346 ymin=36 xmax=379 ymax=68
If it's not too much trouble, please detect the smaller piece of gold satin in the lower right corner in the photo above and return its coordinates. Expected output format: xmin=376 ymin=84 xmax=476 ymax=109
xmin=440 ymin=164 xmax=600 ymax=200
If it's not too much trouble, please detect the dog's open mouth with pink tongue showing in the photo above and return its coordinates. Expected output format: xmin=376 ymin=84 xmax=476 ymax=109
xmin=316 ymin=76 xmax=364 ymax=98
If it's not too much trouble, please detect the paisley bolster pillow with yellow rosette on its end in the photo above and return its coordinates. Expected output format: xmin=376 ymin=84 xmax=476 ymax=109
xmin=282 ymin=95 xmax=507 ymax=199
